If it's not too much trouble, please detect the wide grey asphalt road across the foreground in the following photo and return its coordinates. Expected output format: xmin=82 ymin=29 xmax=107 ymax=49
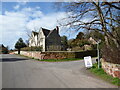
xmin=2 ymin=54 xmax=117 ymax=88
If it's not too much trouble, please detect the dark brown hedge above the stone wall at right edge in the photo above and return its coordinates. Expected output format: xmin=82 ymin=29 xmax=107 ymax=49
xmin=100 ymin=27 xmax=120 ymax=64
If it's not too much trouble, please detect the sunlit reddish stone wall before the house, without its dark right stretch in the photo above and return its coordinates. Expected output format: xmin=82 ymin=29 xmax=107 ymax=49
xmin=14 ymin=51 xmax=75 ymax=60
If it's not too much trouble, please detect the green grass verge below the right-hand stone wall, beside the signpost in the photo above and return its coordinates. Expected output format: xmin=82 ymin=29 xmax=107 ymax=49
xmin=90 ymin=64 xmax=120 ymax=86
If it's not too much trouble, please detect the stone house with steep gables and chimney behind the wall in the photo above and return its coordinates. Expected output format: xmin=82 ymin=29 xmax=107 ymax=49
xmin=29 ymin=26 xmax=61 ymax=51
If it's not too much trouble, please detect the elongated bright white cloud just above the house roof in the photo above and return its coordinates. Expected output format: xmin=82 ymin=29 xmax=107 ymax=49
xmin=27 ymin=12 xmax=66 ymax=29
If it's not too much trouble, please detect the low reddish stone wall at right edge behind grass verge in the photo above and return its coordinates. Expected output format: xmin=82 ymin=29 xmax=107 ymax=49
xmin=101 ymin=59 xmax=120 ymax=78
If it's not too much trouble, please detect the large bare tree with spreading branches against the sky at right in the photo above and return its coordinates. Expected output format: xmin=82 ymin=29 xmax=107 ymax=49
xmin=55 ymin=1 xmax=120 ymax=49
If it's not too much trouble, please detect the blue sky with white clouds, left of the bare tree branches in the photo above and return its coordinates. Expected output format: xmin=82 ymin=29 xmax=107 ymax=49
xmin=0 ymin=2 xmax=79 ymax=48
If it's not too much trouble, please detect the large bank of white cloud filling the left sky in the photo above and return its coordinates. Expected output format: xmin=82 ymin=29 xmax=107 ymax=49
xmin=0 ymin=5 xmax=67 ymax=48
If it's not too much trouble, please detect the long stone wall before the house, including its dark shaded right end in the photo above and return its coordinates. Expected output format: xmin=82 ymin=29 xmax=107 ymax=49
xmin=15 ymin=50 xmax=97 ymax=59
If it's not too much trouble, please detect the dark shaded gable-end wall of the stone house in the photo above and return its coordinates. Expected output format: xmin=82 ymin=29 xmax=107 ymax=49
xmin=45 ymin=30 xmax=61 ymax=51
